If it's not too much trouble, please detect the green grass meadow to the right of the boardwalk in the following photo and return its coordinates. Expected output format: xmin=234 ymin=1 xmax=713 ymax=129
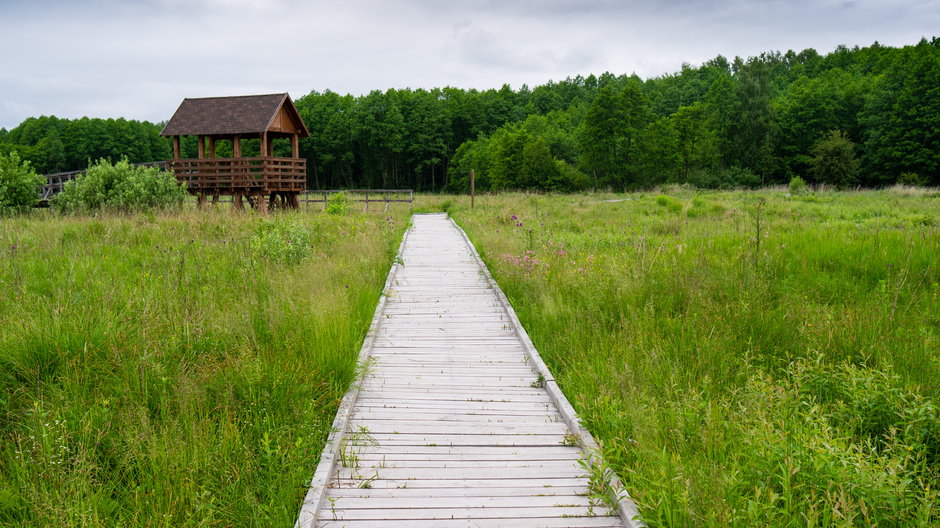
xmin=448 ymin=188 xmax=940 ymax=527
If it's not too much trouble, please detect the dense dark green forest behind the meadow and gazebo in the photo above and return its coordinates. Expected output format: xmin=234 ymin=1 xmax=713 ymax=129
xmin=0 ymin=37 xmax=940 ymax=192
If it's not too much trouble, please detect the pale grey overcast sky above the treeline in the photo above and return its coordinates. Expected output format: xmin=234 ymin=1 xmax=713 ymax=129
xmin=0 ymin=0 xmax=940 ymax=128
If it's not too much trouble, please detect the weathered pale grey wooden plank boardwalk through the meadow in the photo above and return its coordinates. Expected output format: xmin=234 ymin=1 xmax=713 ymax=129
xmin=297 ymin=215 xmax=642 ymax=528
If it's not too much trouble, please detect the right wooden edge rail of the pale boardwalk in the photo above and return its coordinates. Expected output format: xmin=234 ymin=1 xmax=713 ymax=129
xmin=448 ymin=215 xmax=646 ymax=528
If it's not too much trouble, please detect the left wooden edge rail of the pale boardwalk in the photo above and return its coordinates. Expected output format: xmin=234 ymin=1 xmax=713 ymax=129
xmin=294 ymin=216 xmax=413 ymax=528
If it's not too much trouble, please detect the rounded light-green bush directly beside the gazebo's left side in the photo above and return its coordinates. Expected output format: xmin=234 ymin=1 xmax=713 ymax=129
xmin=52 ymin=158 xmax=186 ymax=212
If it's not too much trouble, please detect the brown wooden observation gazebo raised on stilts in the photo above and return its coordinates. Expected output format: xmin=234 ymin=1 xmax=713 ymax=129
xmin=160 ymin=93 xmax=310 ymax=211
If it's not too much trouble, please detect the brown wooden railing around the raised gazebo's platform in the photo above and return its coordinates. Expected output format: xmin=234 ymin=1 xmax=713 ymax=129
xmin=170 ymin=157 xmax=307 ymax=194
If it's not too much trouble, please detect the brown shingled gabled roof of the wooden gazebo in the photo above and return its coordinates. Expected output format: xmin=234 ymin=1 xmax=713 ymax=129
xmin=160 ymin=93 xmax=310 ymax=137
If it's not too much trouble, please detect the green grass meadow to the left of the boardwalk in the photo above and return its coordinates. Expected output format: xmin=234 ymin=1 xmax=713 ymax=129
xmin=0 ymin=208 xmax=407 ymax=527
